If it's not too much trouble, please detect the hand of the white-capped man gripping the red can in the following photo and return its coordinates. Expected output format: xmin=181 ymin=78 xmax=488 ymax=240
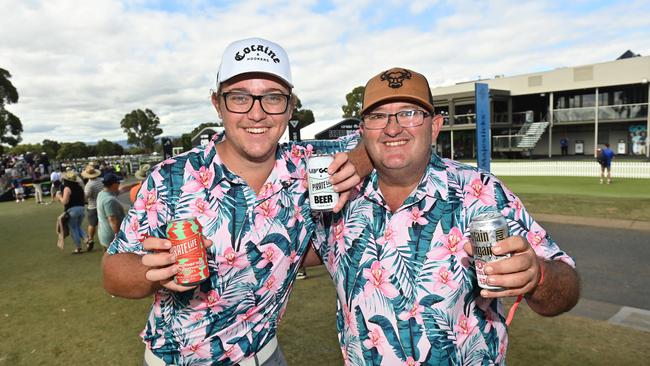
xmin=142 ymin=237 xmax=212 ymax=292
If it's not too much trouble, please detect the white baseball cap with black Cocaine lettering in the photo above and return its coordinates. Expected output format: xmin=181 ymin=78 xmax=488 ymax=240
xmin=217 ymin=38 xmax=293 ymax=88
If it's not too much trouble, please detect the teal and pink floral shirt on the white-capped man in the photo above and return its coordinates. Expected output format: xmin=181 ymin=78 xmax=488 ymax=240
xmin=108 ymin=135 xmax=358 ymax=365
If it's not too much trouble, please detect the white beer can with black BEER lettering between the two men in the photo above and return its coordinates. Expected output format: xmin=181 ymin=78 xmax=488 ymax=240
xmin=307 ymin=154 xmax=339 ymax=212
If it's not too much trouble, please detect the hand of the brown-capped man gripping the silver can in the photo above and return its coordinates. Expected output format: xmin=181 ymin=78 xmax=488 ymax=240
xmin=465 ymin=236 xmax=542 ymax=298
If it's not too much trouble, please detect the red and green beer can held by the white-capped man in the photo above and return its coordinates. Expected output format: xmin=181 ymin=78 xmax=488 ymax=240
xmin=167 ymin=217 xmax=210 ymax=286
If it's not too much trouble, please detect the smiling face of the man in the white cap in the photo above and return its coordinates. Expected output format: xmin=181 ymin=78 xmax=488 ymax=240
xmin=212 ymin=74 xmax=293 ymax=164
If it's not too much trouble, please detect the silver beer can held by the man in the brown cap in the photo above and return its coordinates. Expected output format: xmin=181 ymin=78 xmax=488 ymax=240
xmin=469 ymin=211 xmax=510 ymax=291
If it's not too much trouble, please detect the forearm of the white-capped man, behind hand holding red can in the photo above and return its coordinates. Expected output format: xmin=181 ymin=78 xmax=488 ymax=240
xmin=102 ymin=253 xmax=161 ymax=299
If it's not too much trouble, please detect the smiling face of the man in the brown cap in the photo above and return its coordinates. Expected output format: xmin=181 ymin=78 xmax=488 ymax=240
xmin=362 ymin=102 xmax=440 ymax=181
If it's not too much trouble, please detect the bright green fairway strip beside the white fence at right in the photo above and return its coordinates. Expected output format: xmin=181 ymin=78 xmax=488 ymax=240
xmin=499 ymin=177 xmax=650 ymax=221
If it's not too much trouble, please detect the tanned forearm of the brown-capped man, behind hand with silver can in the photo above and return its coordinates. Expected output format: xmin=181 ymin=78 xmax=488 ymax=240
xmin=526 ymin=261 xmax=580 ymax=316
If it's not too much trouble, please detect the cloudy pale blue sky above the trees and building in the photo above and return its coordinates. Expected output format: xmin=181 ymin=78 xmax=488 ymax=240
xmin=0 ymin=0 xmax=650 ymax=142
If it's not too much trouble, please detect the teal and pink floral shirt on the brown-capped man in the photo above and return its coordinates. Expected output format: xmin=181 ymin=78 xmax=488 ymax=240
xmin=314 ymin=154 xmax=574 ymax=365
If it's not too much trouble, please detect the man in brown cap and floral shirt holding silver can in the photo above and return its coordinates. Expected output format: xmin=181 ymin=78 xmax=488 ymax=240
xmin=315 ymin=68 xmax=579 ymax=365
